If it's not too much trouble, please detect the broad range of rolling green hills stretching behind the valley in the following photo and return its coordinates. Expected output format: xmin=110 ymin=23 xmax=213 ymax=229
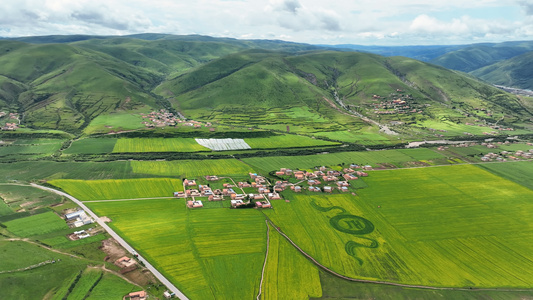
xmin=0 ymin=34 xmax=531 ymax=132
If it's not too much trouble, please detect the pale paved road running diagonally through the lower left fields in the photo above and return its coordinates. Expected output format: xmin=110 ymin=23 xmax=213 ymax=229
xmin=31 ymin=183 xmax=189 ymax=300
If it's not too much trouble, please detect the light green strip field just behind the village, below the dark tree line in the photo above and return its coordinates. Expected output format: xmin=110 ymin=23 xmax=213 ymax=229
xmin=131 ymin=159 xmax=253 ymax=178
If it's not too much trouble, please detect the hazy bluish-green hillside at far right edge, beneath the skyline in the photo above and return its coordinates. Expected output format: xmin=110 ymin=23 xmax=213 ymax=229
xmin=471 ymin=51 xmax=533 ymax=90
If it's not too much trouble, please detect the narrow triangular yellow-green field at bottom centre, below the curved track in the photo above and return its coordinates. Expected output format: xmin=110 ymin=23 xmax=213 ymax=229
xmin=261 ymin=223 xmax=322 ymax=300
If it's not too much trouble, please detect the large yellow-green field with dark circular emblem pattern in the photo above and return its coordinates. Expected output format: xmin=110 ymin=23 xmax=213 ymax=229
xmin=266 ymin=165 xmax=533 ymax=288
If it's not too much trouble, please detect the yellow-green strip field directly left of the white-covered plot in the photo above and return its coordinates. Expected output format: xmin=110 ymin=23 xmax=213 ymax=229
xmin=113 ymin=138 xmax=210 ymax=153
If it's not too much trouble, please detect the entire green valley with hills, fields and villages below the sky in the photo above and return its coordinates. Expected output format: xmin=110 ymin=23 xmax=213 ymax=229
xmin=0 ymin=34 xmax=533 ymax=299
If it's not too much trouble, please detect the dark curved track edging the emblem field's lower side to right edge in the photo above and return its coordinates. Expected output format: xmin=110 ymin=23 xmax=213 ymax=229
xmin=265 ymin=215 xmax=533 ymax=292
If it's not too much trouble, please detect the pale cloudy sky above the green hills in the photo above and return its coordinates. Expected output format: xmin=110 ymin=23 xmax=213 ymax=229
xmin=0 ymin=0 xmax=533 ymax=45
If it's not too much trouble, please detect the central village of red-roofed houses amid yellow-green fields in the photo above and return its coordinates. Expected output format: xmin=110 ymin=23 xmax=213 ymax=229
xmin=174 ymin=164 xmax=372 ymax=209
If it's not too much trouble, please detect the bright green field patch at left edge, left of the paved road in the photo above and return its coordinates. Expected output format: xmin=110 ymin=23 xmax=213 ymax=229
xmin=4 ymin=211 xmax=68 ymax=237
